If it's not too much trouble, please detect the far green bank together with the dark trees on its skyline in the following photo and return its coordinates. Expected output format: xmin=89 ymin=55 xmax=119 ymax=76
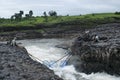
xmin=0 ymin=10 xmax=120 ymax=31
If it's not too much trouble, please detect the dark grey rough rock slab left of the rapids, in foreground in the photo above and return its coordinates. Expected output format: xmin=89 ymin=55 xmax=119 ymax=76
xmin=0 ymin=44 xmax=63 ymax=80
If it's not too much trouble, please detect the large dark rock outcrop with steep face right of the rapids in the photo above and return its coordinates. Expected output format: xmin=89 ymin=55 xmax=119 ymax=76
xmin=68 ymin=23 xmax=120 ymax=75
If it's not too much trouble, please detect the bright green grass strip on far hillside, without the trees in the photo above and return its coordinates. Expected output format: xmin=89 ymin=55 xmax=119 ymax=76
xmin=0 ymin=13 xmax=120 ymax=30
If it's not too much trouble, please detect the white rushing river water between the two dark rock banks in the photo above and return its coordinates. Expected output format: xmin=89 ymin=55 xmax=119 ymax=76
xmin=20 ymin=39 xmax=120 ymax=80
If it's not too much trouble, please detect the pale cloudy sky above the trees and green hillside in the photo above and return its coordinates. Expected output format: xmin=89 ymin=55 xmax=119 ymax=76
xmin=0 ymin=0 xmax=120 ymax=17
